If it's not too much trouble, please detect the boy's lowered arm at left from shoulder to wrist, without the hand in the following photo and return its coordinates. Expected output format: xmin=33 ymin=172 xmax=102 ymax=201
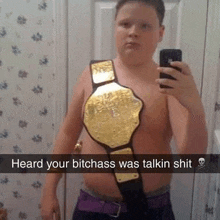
xmin=45 ymin=68 xmax=88 ymax=190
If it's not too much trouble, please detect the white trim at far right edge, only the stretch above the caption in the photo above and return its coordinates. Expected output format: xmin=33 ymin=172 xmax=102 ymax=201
xmin=202 ymin=0 xmax=220 ymax=153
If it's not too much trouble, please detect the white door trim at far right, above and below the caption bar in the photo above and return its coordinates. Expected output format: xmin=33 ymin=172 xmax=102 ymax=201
xmin=192 ymin=0 xmax=220 ymax=220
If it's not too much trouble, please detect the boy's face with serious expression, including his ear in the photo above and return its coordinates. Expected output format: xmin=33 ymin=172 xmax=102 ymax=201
xmin=115 ymin=2 xmax=164 ymax=61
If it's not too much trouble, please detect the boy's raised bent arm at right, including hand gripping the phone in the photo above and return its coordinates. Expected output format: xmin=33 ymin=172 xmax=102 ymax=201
xmin=156 ymin=62 xmax=208 ymax=154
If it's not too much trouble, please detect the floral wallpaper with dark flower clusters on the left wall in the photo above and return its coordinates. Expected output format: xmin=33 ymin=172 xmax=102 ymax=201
xmin=0 ymin=0 xmax=55 ymax=220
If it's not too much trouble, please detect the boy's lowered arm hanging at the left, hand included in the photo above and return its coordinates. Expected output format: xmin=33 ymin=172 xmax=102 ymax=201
xmin=41 ymin=67 xmax=89 ymax=220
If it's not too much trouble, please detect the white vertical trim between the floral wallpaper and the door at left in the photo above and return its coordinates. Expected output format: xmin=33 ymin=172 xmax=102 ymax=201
xmin=51 ymin=0 xmax=68 ymax=219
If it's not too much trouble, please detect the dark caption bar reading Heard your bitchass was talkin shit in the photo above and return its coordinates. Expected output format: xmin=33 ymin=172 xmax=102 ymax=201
xmin=0 ymin=154 xmax=220 ymax=173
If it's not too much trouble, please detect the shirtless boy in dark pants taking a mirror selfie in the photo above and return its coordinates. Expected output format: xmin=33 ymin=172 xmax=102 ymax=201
xmin=42 ymin=0 xmax=207 ymax=220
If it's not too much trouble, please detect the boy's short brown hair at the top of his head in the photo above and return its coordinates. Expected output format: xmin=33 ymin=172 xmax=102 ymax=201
xmin=115 ymin=0 xmax=165 ymax=25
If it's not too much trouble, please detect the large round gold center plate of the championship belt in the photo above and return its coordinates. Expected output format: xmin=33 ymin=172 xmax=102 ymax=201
xmin=84 ymin=82 xmax=143 ymax=148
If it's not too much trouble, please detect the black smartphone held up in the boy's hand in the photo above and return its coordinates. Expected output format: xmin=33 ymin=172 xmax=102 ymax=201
xmin=160 ymin=49 xmax=182 ymax=88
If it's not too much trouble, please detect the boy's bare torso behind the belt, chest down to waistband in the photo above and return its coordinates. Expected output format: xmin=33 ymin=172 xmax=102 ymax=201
xmin=81 ymin=57 xmax=172 ymax=199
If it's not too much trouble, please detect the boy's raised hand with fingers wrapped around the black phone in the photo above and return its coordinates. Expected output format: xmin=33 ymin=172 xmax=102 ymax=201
xmin=156 ymin=61 xmax=200 ymax=110
